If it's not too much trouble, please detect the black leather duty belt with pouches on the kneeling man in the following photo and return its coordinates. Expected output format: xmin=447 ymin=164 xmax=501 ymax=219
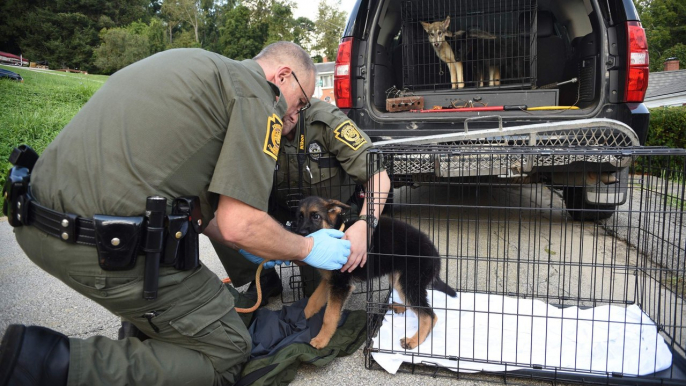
xmin=2 ymin=145 xmax=202 ymax=299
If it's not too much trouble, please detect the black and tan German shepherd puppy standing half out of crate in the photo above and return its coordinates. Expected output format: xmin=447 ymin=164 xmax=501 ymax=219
xmin=295 ymin=196 xmax=457 ymax=349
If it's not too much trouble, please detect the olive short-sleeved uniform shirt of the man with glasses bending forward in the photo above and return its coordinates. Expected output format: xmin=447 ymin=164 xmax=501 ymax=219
xmin=31 ymin=49 xmax=287 ymax=223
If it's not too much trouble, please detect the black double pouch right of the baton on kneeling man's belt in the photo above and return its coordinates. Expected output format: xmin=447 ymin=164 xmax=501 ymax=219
xmin=162 ymin=196 xmax=202 ymax=271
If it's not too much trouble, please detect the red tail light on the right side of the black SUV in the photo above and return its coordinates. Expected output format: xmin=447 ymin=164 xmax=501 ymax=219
xmin=624 ymin=21 xmax=649 ymax=102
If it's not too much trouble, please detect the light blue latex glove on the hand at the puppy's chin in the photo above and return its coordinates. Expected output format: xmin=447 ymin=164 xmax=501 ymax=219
xmin=303 ymin=229 xmax=350 ymax=271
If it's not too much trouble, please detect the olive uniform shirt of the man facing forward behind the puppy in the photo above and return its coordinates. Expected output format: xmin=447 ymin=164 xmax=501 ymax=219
xmin=276 ymin=98 xmax=378 ymax=207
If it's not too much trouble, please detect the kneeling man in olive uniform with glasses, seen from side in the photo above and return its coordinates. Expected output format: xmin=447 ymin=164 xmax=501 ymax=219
xmin=0 ymin=42 xmax=350 ymax=386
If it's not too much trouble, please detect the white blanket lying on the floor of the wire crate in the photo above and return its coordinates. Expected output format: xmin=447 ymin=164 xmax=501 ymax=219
xmin=373 ymin=291 xmax=672 ymax=375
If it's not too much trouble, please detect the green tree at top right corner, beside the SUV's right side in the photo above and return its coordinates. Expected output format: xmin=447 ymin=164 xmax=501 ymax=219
xmin=634 ymin=0 xmax=686 ymax=71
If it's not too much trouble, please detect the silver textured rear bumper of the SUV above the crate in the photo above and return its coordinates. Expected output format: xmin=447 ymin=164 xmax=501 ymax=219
xmin=375 ymin=119 xmax=640 ymax=178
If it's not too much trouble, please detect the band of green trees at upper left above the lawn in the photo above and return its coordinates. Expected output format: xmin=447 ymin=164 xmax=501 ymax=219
xmin=0 ymin=0 xmax=346 ymax=74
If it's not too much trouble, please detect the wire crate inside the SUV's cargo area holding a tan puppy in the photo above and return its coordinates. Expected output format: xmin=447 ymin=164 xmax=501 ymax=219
xmin=401 ymin=0 xmax=537 ymax=91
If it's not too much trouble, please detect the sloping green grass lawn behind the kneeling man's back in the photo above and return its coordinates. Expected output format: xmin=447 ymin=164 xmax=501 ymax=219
xmin=0 ymin=65 xmax=108 ymax=186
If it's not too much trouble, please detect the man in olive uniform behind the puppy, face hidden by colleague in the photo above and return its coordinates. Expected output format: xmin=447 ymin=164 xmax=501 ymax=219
xmin=224 ymin=98 xmax=390 ymax=304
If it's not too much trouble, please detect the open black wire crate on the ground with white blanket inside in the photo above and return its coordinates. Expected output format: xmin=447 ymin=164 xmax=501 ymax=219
xmin=365 ymin=145 xmax=686 ymax=385
